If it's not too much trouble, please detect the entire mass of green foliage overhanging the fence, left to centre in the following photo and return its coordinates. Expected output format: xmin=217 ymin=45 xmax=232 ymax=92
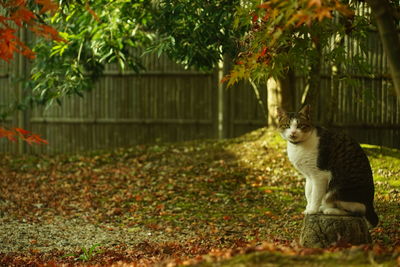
xmin=18 ymin=0 xmax=247 ymax=111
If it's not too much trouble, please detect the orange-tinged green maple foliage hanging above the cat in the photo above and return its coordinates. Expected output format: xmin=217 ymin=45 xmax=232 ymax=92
xmin=227 ymin=0 xmax=369 ymax=91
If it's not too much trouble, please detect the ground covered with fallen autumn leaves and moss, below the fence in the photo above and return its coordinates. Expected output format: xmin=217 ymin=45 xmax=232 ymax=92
xmin=0 ymin=129 xmax=400 ymax=266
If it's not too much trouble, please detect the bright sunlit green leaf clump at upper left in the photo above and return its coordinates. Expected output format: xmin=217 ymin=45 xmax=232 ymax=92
xmin=29 ymin=0 xmax=151 ymax=107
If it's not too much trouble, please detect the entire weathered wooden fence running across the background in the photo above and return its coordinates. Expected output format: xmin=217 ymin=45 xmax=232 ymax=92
xmin=0 ymin=25 xmax=400 ymax=153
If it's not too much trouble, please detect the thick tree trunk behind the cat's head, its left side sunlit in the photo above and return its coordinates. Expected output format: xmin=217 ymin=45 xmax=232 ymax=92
xmin=267 ymin=70 xmax=296 ymax=127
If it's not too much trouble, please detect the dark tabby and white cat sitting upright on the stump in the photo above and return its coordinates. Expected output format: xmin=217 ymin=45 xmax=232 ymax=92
xmin=278 ymin=105 xmax=379 ymax=226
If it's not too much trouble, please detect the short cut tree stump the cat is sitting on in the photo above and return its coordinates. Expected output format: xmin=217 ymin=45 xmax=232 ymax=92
xmin=300 ymin=214 xmax=371 ymax=248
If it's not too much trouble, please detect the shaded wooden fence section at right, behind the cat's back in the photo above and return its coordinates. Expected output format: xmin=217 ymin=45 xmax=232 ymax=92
xmin=316 ymin=28 xmax=400 ymax=148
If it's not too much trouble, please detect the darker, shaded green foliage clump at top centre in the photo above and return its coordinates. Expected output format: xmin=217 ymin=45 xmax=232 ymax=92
xmin=150 ymin=0 xmax=244 ymax=70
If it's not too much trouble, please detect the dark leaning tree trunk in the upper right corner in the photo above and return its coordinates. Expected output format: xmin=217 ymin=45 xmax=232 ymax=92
xmin=367 ymin=0 xmax=400 ymax=98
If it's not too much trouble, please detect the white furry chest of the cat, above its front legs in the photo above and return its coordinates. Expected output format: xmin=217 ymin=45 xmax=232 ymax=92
xmin=287 ymin=134 xmax=319 ymax=176
